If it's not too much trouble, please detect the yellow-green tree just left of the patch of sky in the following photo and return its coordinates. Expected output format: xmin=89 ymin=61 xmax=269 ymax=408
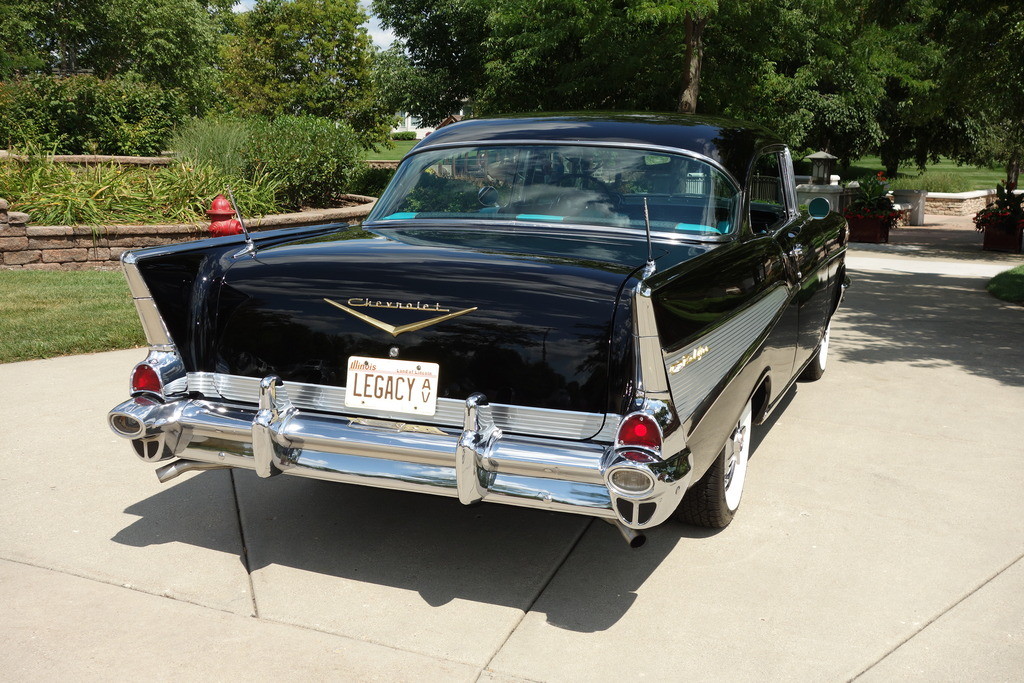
xmin=223 ymin=0 xmax=393 ymax=143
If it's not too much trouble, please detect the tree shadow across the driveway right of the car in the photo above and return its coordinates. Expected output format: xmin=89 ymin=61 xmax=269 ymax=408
xmin=831 ymin=266 xmax=1024 ymax=386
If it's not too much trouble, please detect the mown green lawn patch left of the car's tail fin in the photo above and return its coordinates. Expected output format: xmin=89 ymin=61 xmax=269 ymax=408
xmin=0 ymin=270 xmax=145 ymax=362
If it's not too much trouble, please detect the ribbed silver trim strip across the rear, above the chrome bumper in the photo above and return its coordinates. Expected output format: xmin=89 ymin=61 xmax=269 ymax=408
xmin=187 ymin=373 xmax=622 ymax=443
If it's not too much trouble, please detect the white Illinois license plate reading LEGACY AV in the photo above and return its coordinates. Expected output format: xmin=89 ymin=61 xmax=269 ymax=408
xmin=345 ymin=355 xmax=440 ymax=416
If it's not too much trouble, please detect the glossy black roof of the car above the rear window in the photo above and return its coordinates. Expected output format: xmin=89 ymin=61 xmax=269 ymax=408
xmin=415 ymin=112 xmax=780 ymax=181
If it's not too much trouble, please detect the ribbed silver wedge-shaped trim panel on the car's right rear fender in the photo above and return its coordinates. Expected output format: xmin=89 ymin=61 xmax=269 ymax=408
xmin=665 ymin=286 xmax=788 ymax=420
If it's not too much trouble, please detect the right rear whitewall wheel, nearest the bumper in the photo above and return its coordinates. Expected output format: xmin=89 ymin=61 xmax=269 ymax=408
xmin=674 ymin=401 xmax=753 ymax=528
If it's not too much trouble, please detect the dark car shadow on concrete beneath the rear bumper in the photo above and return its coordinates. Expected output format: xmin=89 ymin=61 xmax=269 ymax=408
xmin=113 ymin=413 xmax=782 ymax=632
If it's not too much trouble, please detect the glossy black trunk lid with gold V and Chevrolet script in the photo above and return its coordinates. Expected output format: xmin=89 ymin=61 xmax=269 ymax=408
xmin=210 ymin=229 xmax=642 ymax=413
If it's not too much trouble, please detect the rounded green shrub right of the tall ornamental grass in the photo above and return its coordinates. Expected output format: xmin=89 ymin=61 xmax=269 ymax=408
xmin=245 ymin=116 xmax=362 ymax=209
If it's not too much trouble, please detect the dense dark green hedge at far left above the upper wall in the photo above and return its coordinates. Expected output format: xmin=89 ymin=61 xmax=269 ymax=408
xmin=0 ymin=76 xmax=186 ymax=155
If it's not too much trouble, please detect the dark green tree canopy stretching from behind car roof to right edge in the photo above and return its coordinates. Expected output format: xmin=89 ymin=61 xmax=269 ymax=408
xmin=374 ymin=0 xmax=1024 ymax=179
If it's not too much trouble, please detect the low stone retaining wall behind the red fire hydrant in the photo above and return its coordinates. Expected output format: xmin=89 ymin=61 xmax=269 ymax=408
xmin=0 ymin=195 xmax=376 ymax=270
